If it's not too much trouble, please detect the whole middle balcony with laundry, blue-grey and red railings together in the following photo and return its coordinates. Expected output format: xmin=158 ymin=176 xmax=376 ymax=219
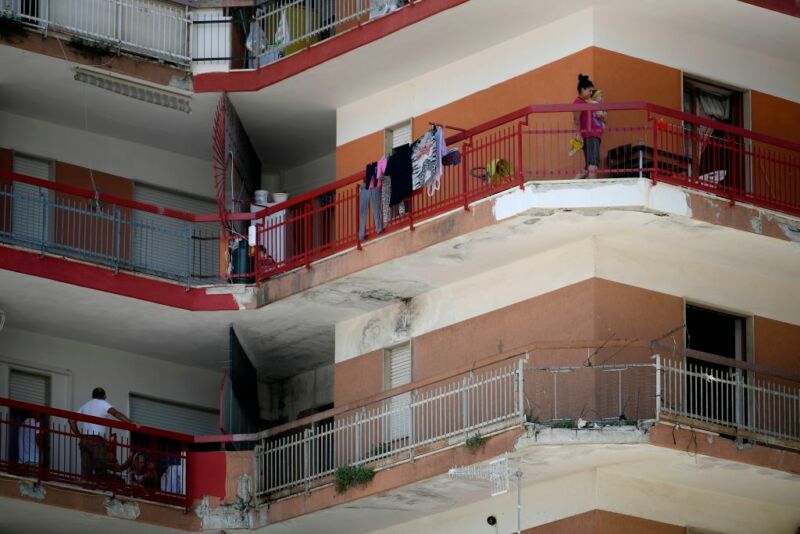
xmin=0 ymin=103 xmax=800 ymax=298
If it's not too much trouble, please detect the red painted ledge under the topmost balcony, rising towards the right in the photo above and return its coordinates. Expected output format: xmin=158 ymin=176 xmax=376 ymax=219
xmin=193 ymin=0 xmax=468 ymax=93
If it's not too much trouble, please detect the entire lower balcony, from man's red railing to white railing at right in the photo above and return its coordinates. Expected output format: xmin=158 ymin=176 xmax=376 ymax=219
xmin=0 ymin=339 xmax=800 ymax=528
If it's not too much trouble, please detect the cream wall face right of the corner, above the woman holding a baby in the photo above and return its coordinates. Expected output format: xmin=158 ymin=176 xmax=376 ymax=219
xmin=593 ymin=0 xmax=800 ymax=102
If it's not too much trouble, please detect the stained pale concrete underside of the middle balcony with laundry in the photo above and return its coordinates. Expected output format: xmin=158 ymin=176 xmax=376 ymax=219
xmin=0 ymin=193 xmax=800 ymax=381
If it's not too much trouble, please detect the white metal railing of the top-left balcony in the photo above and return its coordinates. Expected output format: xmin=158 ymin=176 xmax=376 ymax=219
xmin=0 ymin=0 xmax=191 ymax=66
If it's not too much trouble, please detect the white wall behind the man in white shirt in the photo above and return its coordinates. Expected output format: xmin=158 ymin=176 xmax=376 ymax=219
xmin=0 ymin=328 xmax=222 ymax=414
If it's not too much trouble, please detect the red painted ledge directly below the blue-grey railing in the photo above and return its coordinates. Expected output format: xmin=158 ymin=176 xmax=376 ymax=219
xmin=0 ymin=246 xmax=239 ymax=311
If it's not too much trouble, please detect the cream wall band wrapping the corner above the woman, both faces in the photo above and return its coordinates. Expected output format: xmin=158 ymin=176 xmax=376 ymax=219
xmin=336 ymin=0 xmax=800 ymax=146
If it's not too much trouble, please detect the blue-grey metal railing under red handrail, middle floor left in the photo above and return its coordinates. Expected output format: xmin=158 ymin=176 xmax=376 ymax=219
xmin=0 ymin=182 xmax=219 ymax=284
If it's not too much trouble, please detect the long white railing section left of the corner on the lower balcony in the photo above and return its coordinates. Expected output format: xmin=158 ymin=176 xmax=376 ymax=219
xmin=256 ymin=360 xmax=524 ymax=496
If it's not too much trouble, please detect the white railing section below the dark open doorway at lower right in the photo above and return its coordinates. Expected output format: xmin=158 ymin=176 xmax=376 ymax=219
xmin=659 ymin=360 xmax=800 ymax=442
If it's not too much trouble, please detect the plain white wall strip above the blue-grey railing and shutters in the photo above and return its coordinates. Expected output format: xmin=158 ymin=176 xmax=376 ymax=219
xmin=0 ymin=111 xmax=214 ymax=198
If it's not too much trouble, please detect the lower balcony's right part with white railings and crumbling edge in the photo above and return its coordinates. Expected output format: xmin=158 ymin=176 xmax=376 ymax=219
xmin=230 ymin=339 xmax=800 ymax=526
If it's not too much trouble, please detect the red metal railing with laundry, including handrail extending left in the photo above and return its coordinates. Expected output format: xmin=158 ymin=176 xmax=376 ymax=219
xmin=0 ymin=102 xmax=800 ymax=281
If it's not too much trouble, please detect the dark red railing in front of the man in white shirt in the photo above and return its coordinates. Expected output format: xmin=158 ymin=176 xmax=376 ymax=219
xmin=0 ymin=398 xmax=194 ymax=508
